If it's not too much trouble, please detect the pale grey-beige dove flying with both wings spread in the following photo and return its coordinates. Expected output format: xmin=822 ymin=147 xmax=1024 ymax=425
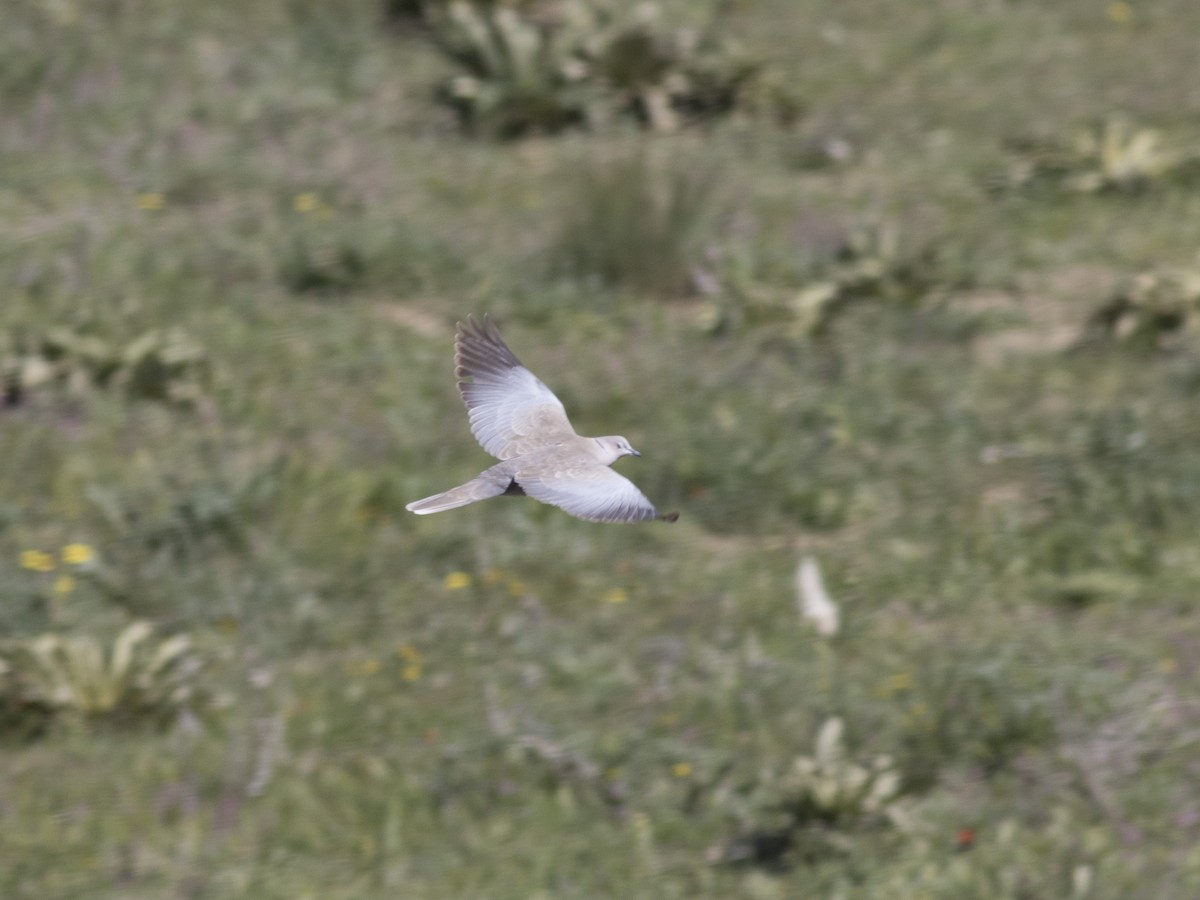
xmin=406 ymin=316 xmax=679 ymax=522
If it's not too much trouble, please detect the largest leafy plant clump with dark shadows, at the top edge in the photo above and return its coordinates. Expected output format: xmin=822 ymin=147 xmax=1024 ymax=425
xmin=425 ymin=0 xmax=761 ymax=138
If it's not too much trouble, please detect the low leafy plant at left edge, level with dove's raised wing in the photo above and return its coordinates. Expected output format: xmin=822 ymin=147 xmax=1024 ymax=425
xmin=0 ymin=328 xmax=211 ymax=406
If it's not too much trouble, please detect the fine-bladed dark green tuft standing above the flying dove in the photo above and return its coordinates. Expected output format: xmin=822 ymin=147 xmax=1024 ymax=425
xmin=551 ymin=154 xmax=718 ymax=295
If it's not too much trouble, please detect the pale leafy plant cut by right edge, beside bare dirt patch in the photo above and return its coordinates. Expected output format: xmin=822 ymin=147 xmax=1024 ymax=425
xmin=1084 ymin=268 xmax=1200 ymax=348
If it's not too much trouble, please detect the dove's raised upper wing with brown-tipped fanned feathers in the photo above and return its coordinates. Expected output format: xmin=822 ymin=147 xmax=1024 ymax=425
xmin=455 ymin=316 xmax=575 ymax=460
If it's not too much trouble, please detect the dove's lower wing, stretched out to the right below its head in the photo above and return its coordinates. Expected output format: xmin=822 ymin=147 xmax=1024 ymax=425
xmin=516 ymin=460 xmax=660 ymax=522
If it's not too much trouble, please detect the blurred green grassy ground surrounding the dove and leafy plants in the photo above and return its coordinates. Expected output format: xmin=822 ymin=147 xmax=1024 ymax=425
xmin=0 ymin=0 xmax=1200 ymax=900
